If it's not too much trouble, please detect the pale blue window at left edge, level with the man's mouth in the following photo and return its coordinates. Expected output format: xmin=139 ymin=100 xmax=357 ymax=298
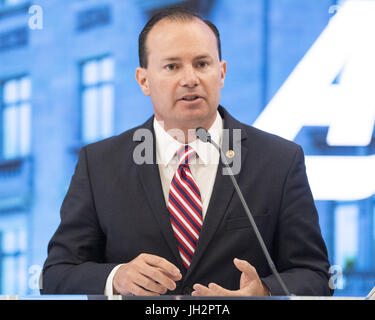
xmin=1 ymin=76 xmax=31 ymax=160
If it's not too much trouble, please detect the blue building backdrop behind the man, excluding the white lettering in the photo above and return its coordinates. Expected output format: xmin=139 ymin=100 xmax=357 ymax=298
xmin=0 ymin=0 xmax=375 ymax=296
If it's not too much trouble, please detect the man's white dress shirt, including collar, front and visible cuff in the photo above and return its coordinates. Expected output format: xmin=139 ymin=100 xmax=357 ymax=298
xmin=104 ymin=112 xmax=223 ymax=296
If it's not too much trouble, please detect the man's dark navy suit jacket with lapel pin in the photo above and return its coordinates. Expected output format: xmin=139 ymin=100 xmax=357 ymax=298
xmin=41 ymin=107 xmax=332 ymax=295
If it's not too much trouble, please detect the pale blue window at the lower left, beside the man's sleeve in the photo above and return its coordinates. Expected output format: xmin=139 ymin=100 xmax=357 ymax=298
xmin=0 ymin=218 xmax=27 ymax=295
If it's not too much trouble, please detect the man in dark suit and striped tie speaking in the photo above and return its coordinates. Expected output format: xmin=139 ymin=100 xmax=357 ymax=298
xmin=42 ymin=9 xmax=331 ymax=296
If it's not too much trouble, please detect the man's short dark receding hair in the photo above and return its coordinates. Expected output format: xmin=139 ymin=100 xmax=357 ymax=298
xmin=138 ymin=7 xmax=221 ymax=68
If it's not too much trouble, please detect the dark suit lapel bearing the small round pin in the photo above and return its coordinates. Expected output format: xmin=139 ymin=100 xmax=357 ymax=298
xmin=186 ymin=107 xmax=247 ymax=278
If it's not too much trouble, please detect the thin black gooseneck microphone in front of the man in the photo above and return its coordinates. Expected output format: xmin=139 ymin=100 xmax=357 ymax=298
xmin=195 ymin=127 xmax=291 ymax=296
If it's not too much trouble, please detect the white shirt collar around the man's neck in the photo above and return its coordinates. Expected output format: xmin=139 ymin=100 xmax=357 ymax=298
xmin=153 ymin=112 xmax=223 ymax=166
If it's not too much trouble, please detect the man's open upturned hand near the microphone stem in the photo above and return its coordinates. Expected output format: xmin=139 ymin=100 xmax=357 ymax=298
xmin=191 ymin=258 xmax=269 ymax=296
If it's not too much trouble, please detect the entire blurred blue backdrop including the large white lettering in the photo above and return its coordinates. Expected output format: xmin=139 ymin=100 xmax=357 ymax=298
xmin=0 ymin=0 xmax=375 ymax=296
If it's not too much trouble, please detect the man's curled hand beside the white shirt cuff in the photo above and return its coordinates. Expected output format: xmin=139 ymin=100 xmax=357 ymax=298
xmin=113 ymin=253 xmax=182 ymax=296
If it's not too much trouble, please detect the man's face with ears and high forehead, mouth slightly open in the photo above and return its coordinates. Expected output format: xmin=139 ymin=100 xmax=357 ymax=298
xmin=136 ymin=19 xmax=226 ymax=130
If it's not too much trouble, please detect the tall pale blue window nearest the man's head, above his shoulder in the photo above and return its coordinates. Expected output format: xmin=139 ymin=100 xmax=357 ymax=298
xmin=81 ymin=56 xmax=114 ymax=143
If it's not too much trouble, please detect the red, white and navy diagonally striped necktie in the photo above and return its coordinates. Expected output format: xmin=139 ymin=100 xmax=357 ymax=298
xmin=168 ymin=145 xmax=203 ymax=269
